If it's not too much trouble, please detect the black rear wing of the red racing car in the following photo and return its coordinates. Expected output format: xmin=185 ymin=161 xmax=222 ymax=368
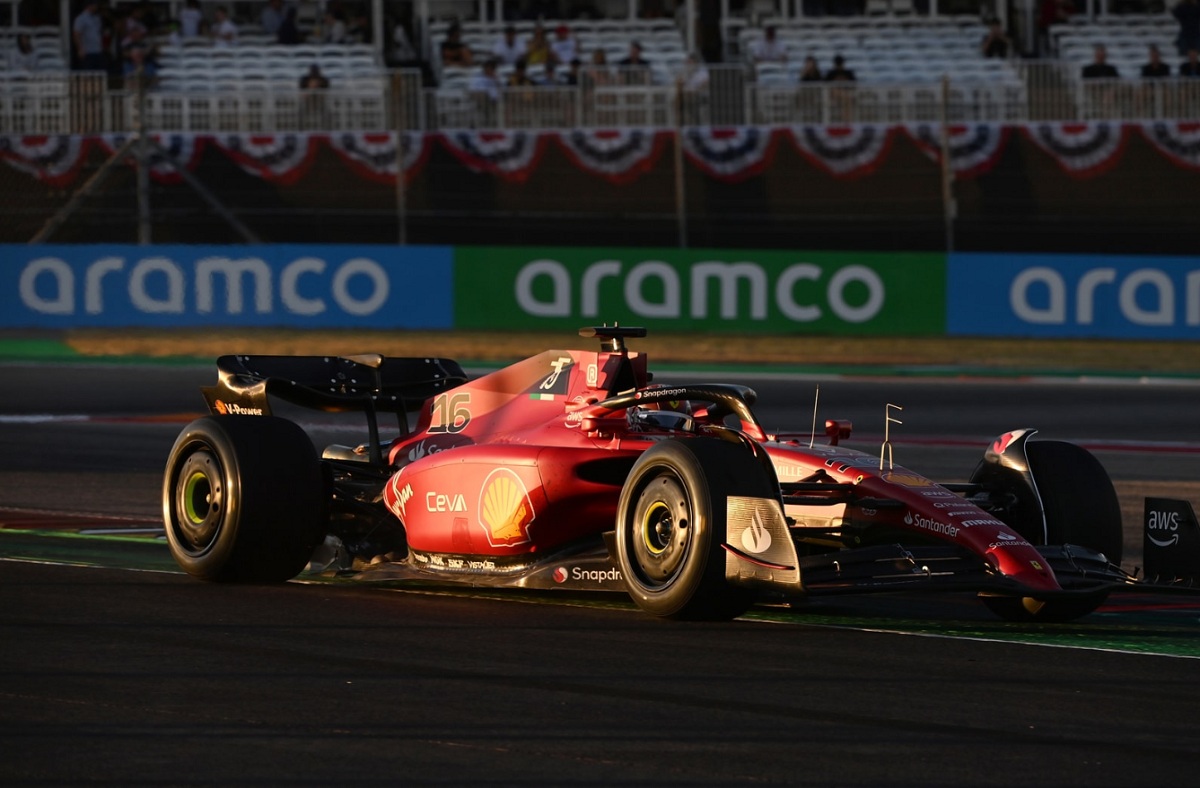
xmin=200 ymin=353 xmax=467 ymax=416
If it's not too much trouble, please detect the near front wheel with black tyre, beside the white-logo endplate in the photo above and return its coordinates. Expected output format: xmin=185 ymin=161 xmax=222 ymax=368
xmin=617 ymin=438 xmax=772 ymax=620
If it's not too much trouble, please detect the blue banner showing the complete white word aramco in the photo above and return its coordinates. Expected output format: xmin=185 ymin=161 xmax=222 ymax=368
xmin=0 ymin=245 xmax=454 ymax=329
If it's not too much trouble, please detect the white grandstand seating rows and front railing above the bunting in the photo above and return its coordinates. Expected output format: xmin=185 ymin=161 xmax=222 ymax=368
xmin=0 ymin=6 xmax=1200 ymax=133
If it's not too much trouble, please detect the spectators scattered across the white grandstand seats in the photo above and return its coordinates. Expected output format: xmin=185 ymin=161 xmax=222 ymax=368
xmin=4 ymin=0 xmax=1200 ymax=103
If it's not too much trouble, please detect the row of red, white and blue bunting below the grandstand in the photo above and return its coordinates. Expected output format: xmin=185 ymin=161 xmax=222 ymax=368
xmin=0 ymin=121 xmax=1200 ymax=188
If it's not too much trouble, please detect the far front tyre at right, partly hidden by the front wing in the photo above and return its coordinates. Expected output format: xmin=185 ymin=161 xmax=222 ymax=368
xmin=983 ymin=440 xmax=1124 ymax=621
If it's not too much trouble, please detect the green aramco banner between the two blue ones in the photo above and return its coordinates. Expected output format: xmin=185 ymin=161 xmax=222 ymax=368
xmin=455 ymin=247 xmax=946 ymax=336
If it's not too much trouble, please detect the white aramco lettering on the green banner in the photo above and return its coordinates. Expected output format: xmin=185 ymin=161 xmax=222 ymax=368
xmin=515 ymin=259 xmax=886 ymax=323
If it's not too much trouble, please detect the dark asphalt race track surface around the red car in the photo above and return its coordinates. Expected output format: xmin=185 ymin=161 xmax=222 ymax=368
xmin=0 ymin=363 xmax=1200 ymax=786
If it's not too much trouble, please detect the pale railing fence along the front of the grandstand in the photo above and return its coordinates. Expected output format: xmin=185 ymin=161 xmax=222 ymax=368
xmin=7 ymin=61 xmax=1200 ymax=134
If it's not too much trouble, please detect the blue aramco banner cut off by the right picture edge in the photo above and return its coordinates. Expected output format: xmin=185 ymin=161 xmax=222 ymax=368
xmin=946 ymin=253 xmax=1200 ymax=339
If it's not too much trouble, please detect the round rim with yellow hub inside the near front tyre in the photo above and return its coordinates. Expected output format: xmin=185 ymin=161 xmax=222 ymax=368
xmin=630 ymin=474 xmax=692 ymax=588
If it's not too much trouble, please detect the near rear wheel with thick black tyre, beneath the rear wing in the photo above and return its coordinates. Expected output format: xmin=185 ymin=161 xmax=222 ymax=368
xmin=162 ymin=416 xmax=325 ymax=583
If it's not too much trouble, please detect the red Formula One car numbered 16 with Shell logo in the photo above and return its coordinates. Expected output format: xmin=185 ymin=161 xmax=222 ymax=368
xmin=163 ymin=327 xmax=1133 ymax=620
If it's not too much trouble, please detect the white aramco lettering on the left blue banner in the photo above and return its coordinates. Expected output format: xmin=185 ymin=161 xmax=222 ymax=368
xmin=18 ymin=255 xmax=391 ymax=317
